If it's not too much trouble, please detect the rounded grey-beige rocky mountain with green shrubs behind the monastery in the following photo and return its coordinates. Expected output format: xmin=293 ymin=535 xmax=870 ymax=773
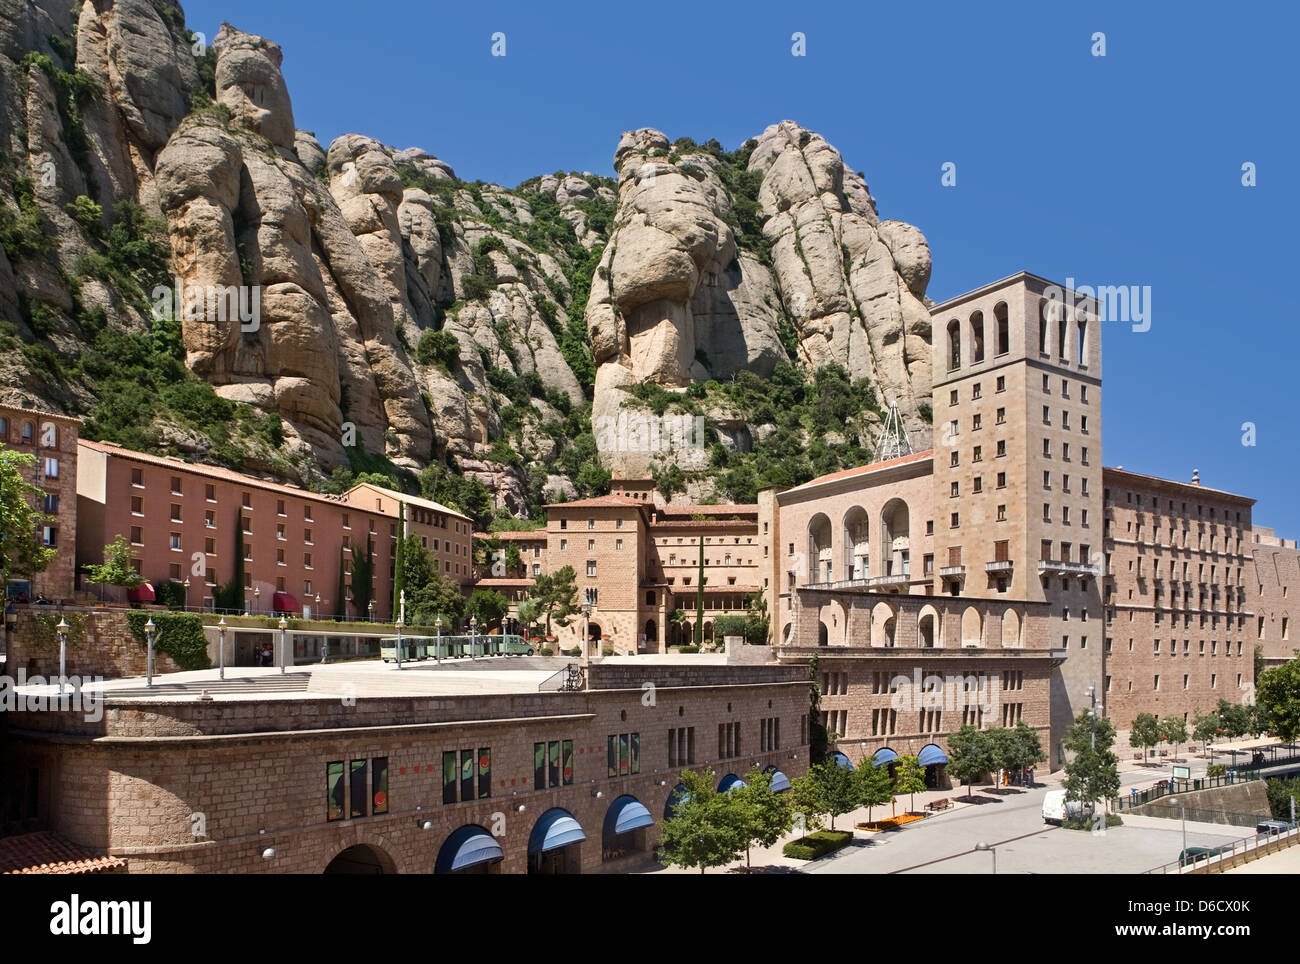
xmin=0 ymin=0 xmax=930 ymax=514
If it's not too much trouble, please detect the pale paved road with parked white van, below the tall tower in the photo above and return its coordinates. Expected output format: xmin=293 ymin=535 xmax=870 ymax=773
xmin=803 ymin=772 xmax=1255 ymax=874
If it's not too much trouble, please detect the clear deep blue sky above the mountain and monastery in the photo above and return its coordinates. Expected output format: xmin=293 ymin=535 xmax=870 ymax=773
xmin=182 ymin=0 xmax=1300 ymax=538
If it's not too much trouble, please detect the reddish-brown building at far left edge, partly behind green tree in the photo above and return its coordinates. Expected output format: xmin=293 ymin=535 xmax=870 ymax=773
xmin=0 ymin=405 xmax=81 ymax=603
